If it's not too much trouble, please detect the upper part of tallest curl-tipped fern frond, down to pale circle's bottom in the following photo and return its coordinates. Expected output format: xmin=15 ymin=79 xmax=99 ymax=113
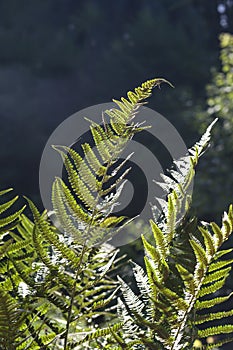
xmin=52 ymin=79 xmax=170 ymax=246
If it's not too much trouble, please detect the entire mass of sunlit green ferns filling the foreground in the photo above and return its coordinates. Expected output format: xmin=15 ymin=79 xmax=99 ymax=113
xmin=0 ymin=79 xmax=233 ymax=350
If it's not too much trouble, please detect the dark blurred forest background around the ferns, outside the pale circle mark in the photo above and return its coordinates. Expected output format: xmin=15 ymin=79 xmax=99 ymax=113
xmin=0 ymin=0 xmax=233 ymax=348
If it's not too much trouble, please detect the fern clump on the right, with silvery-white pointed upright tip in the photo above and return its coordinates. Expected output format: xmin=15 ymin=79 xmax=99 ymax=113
xmin=118 ymin=119 xmax=233 ymax=350
